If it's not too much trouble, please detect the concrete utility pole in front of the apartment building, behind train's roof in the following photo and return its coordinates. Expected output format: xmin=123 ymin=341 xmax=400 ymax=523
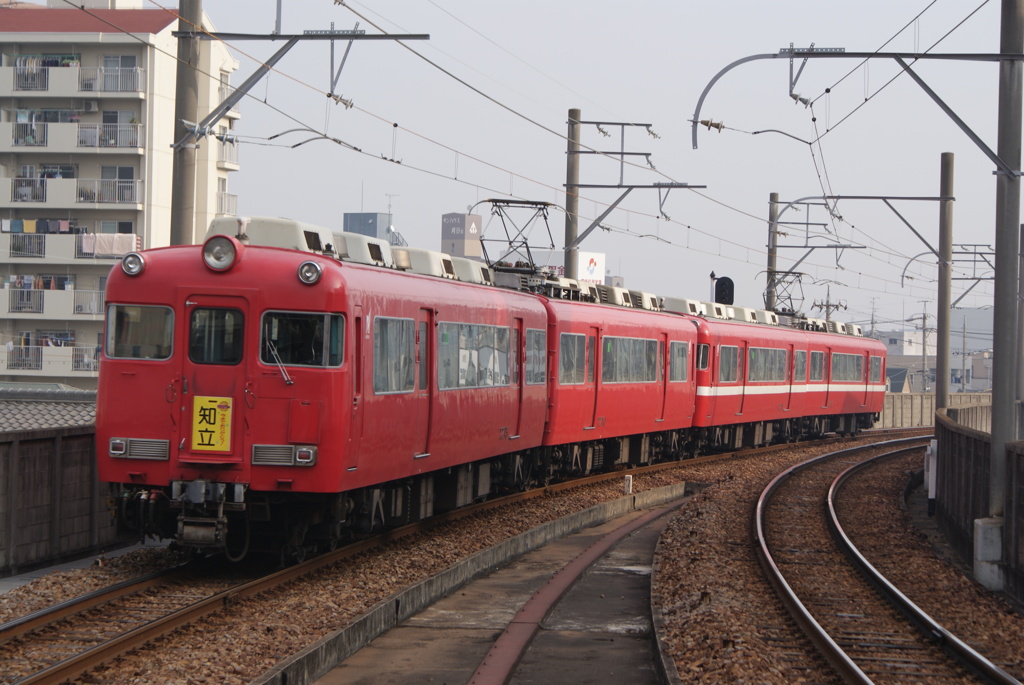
xmin=171 ymin=0 xmax=203 ymax=245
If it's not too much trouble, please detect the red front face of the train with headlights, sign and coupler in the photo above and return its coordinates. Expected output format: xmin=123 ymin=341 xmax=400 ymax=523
xmin=96 ymin=236 xmax=351 ymax=558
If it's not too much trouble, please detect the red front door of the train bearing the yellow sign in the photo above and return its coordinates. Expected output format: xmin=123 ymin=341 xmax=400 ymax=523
xmin=178 ymin=290 xmax=247 ymax=464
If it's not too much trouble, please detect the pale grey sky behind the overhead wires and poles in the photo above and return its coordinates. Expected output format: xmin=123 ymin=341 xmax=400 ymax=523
xmin=188 ymin=0 xmax=999 ymax=329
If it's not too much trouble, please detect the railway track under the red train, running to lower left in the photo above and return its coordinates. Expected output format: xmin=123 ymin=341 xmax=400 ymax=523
xmin=0 ymin=430 xmax=929 ymax=685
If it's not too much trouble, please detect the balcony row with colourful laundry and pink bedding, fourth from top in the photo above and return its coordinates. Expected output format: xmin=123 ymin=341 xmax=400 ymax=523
xmin=0 ymin=232 xmax=141 ymax=264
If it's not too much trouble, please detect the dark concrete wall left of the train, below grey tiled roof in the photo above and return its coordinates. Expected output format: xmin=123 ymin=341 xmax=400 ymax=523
xmin=0 ymin=426 xmax=117 ymax=576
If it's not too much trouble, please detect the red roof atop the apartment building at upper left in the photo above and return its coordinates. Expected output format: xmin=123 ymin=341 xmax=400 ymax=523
xmin=0 ymin=7 xmax=177 ymax=34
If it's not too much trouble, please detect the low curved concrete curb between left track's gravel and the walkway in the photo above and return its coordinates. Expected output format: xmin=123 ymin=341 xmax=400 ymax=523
xmin=252 ymin=483 xmax=686 ymax=685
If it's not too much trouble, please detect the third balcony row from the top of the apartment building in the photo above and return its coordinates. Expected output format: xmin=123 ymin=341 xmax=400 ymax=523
xmin=0 ymin=178 xmax=143 ymax=206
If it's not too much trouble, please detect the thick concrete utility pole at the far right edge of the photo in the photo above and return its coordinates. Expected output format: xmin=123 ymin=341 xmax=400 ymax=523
xmin=988 ymin=0 xmax=1024 ymax=519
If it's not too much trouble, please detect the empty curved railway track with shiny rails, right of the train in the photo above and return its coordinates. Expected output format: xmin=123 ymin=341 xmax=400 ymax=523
xmin=754 ymin=438 xmax=1018 ymax=683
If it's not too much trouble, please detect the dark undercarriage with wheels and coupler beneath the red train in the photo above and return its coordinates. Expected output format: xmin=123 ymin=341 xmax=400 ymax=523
xmin=118 ymin=414 xmax=878 ymax=563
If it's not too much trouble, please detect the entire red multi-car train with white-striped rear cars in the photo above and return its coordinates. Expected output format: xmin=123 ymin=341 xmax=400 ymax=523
xmin=96 ymin=219 xmax=885 ymax=559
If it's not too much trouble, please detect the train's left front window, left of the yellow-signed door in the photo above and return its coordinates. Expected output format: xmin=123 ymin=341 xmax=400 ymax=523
xmin=104 ymin=304 xmax=174 ymax=359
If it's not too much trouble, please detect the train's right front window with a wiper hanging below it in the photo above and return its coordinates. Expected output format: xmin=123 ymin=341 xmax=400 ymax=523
xmin=259 ymin=311 xmax=345 ymax=367
